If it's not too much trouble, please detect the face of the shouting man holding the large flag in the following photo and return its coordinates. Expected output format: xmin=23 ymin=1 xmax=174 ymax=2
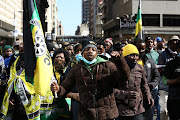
xmin=83 ymin=47 xmax=97 ymax=61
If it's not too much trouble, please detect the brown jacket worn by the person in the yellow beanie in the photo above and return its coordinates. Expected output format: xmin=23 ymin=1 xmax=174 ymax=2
xmin=114 ymin=64 xmax=151 ymax=116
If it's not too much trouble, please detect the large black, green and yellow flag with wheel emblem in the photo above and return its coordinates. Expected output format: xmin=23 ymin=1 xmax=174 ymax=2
xmin=23 ymin=0 xmax=53 ymax=96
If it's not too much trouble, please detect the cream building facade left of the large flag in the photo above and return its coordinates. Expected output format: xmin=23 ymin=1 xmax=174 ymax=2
xmin=0 ymin=0 xmax=23 ymax=45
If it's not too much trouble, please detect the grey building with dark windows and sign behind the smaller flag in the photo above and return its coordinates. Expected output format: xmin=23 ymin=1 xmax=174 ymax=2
xmin=101 ymin=0 xmax=180 ymax=41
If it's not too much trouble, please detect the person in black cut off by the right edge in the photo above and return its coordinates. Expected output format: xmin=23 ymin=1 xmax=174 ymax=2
xmin=164 ymin=41 xmax=180 ymax=120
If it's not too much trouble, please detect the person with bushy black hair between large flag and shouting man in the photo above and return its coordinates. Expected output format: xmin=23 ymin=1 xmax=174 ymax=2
xmin=52 ymin=48 xmax=72 ymax=120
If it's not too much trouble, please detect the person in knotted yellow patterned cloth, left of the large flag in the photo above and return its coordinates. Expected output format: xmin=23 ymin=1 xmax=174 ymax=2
xmin=0 ymin=42 xmax=40 ymax=120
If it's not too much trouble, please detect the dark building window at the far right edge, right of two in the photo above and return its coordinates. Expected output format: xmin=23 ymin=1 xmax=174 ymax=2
xmin=163 ymin=15 xmax=180 ymax=26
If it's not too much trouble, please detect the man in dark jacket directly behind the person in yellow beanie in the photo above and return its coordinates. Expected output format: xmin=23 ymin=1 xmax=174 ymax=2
xmin=135 ymin=39 xmax=160 ymax=120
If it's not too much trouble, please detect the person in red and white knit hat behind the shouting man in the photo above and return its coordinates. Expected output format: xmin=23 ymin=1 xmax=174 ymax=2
xmin=104 ymin=38 xmax=113 ymax=54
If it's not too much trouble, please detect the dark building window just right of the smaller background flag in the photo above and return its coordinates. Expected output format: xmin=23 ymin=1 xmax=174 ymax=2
xmin=142 ymin=14 xmax=160 ymax=26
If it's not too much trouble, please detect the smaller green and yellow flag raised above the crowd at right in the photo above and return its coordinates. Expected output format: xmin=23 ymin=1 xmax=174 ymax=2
xmin=135 ymin=0 xmax=143 ymax=40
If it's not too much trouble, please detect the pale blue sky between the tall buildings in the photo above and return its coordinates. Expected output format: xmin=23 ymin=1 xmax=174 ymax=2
xmin=57 ymin=0 xmax=82 ymax=35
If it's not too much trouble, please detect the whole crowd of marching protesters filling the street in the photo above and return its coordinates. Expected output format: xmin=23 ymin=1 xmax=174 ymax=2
xmin=0 ymin=35 xmax=180 ymax=120
